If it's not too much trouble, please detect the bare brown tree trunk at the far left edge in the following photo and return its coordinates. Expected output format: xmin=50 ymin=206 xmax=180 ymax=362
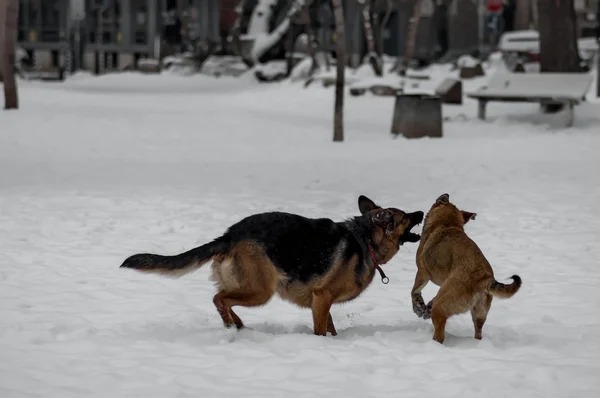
xmin=1 ymin=0 xmax=19 ymax=109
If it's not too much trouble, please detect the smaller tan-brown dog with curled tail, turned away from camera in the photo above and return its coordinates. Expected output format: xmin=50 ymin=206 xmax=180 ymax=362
xmin=411 ymin=194 xmax=521 ymax=344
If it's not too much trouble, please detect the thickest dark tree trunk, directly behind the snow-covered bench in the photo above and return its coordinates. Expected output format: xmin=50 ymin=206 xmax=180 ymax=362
xmin=537 ymin=0 xmax=581 ymax=72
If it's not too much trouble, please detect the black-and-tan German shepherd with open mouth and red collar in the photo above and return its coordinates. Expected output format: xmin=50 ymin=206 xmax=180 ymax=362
xmin=121 ymin=195 xmax=423 ymax=336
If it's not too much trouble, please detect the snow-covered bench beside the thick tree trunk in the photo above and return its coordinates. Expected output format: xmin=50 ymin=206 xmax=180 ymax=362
xmin=467 ymin=73 xmax=592 ymax=127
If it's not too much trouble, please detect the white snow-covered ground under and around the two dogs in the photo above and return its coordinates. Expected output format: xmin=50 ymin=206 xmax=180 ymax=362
xmin=0 ymin=63 xmax=600 ymax=398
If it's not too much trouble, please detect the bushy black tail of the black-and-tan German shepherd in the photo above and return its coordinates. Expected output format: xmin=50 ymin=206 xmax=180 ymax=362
xmin=120 ymin=236 xmax=229 ymax=278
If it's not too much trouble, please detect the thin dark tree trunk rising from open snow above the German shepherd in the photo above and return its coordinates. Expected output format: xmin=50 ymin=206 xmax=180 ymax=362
xmin=332 ymin=0 xmax=346 ymax=141
